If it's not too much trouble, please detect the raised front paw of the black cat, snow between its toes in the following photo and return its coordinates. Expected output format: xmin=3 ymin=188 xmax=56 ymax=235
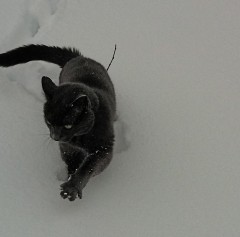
xmin=60 ymin=179 xmax=82 ymax=201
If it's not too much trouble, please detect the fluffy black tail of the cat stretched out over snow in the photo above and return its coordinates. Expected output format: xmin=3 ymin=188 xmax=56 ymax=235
xmin=0 ymin=44 xmax=81 ymax=67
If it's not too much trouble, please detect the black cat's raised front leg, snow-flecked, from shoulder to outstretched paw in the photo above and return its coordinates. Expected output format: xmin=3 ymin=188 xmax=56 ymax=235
xmin=60 ymin=148 xmax=112 ymax=201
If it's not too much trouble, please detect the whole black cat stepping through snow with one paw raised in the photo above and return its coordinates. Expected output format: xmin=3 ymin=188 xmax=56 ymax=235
xmin=0 ymin=45 xmax=116 ymax=201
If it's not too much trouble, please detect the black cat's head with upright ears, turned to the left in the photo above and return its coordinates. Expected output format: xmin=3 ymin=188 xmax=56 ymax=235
xmin=42 ymin=77 xmax=94 ymax=142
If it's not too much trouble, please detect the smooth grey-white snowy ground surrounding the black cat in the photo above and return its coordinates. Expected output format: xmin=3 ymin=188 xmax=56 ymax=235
xmin=0 ymin=0 xmax=240 ymax=237
